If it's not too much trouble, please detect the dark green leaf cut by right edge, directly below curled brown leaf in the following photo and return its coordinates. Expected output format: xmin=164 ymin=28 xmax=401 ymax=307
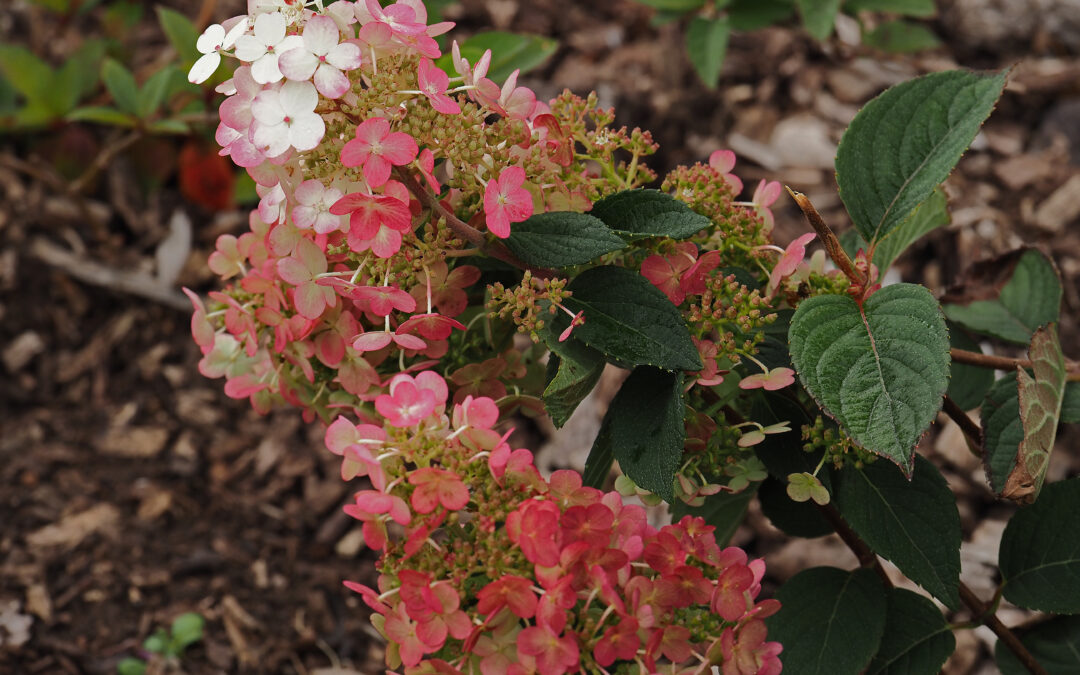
xmin=998 ymin=478 xmax=1080 ymax=615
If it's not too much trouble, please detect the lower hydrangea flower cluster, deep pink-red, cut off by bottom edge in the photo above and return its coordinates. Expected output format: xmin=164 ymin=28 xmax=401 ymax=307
xmin=326 ymin=370 xmax=781 ymax=675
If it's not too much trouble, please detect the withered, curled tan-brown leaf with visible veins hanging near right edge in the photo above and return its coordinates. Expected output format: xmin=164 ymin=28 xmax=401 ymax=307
xmin=1001 ymin=324 xmax=1068 ymax=503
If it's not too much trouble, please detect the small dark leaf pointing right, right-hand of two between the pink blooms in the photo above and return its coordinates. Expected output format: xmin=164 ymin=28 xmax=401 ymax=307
xmin=590 ymin=190 xmax=712 ymax=241
